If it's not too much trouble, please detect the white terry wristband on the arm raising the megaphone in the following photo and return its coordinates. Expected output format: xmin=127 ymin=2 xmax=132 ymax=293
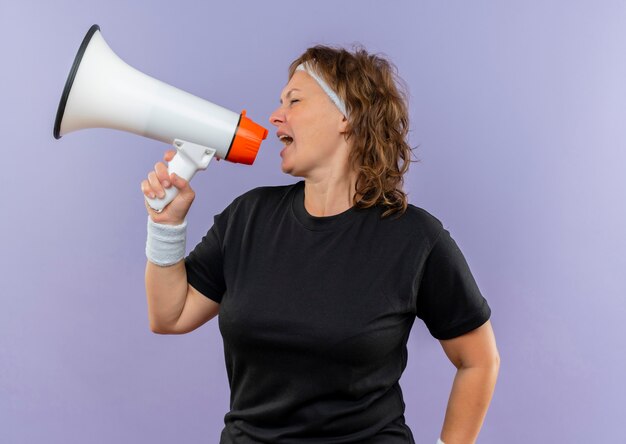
xmin=146 ymin=216 xmax=187 ymax=267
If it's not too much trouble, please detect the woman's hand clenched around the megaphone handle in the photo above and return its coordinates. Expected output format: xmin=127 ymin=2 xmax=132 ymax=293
xmin=141 ymin=150 xmax=196 ymax=225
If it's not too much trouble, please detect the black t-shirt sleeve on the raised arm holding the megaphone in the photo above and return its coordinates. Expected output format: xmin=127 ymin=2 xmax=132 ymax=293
xmin=185 ymin=206 xmax=230 ymax=303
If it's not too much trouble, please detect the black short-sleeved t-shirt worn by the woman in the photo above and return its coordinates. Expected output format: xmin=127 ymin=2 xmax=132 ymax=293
xmin=185 ymin=181 xmax=491 ymax=444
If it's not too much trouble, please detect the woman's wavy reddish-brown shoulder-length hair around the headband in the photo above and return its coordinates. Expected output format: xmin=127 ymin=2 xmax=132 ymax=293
xmin=289 ymin=45 xmax=419 ymax=217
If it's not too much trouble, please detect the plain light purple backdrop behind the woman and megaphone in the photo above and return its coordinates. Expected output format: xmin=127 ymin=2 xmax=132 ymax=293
xmin=0 ymin=0 xmax=626 ymax=444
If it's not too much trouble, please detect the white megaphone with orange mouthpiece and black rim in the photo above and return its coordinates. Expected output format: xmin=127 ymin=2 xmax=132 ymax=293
xmin=53 ymin=25 xmax=267 ymax=211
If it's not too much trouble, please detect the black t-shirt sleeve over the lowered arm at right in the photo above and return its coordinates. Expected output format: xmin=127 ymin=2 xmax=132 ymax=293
xmin=416 ymin=228 xmax=491 ymax=339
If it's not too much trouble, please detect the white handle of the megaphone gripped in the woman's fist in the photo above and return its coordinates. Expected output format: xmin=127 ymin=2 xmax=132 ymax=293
xmin=146 ymin=139 xmax=215 ymax=213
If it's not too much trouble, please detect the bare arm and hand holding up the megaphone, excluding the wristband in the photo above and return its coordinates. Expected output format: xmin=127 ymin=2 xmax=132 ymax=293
xmin=141 ymin=151 xmax=220 ymax=334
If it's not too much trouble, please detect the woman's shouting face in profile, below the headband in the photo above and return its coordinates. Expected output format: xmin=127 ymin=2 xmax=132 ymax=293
xmin=270 ymin=71 xmax=347 ymax=177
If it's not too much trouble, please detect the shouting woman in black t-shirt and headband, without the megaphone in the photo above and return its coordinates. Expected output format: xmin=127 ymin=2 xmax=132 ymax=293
xmin=142 ymin=46 xmax=499 ymax=444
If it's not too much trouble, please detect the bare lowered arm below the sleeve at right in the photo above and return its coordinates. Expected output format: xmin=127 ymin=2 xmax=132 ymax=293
xmin=439 ymin=321 xmax=500 ymax=444
